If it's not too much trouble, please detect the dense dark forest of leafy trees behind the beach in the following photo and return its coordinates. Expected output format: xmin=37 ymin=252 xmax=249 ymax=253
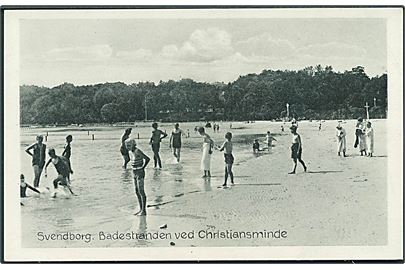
xmin=20 ymin=65 xmax=387 ymax=124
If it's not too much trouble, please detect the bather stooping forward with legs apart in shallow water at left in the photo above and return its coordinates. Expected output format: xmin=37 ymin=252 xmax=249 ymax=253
xmin=45 ymin=148 xmax=73 ymax=196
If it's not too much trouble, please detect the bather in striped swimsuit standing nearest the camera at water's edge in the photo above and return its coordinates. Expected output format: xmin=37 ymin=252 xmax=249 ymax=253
xmin=125 ymin=139 xmax=150 ymax=216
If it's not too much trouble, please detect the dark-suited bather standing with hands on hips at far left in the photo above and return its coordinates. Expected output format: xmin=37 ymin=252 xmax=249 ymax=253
xmin=25 ymin=135 xmax=46 ymax=188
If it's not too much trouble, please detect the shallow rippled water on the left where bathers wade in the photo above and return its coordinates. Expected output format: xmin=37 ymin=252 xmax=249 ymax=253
xmin=21 ymin=123 xmax=280 ymax=246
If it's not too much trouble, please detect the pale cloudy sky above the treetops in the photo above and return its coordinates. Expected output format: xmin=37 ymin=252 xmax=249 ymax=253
xmin=19 ymin=18 xmax=387 ymax=87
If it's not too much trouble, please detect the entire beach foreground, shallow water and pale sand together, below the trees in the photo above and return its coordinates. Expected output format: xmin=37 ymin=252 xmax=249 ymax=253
xmin=21 ymin=120 xmax=388 ymax=247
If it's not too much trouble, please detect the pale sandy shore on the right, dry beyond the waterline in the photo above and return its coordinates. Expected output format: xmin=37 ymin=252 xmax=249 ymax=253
xmin=93 ymin=121 xmax=387 ymax=246
